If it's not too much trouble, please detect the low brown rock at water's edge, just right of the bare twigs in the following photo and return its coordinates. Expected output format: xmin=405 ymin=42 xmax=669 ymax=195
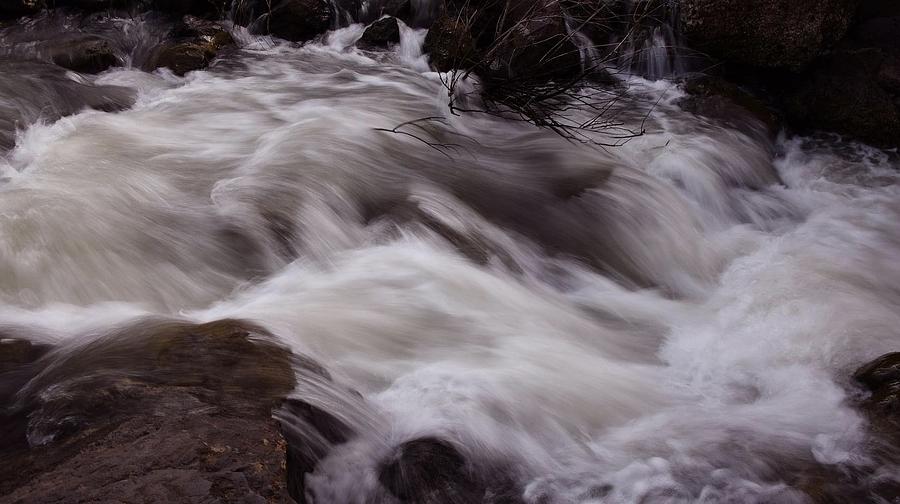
xmin=678 ymin=76 xmax=781 ymax=137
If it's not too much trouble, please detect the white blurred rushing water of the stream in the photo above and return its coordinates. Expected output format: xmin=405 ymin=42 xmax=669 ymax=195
xmin=0 ymin=8 xmax=900 ymax=503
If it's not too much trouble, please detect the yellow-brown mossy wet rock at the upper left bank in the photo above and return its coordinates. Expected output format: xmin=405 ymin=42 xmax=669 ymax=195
xmin=145 ymin=16 xmax=234 ymax=76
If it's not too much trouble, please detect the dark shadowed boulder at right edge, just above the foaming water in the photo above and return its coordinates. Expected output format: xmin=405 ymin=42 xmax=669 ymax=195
xmin=785 ymin=49 xmax=900 ymax=147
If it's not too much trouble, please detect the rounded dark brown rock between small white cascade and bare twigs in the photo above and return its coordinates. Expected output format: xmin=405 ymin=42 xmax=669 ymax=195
xmin=423 ymin=16 xmax=480 ymax=72
